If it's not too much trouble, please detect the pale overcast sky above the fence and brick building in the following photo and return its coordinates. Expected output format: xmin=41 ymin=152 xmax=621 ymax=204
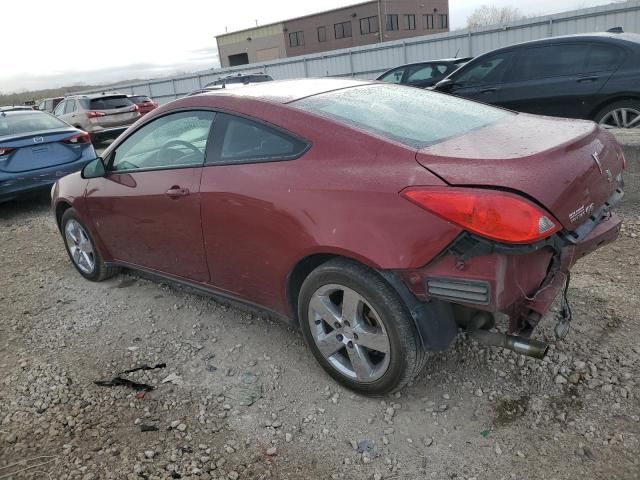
xmin=0 ymin=0 xmax=628 ymax=93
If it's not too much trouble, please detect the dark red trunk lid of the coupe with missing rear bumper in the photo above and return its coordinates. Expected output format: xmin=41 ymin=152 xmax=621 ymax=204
xmin=416 ymin=114 xmax=623 ymax=230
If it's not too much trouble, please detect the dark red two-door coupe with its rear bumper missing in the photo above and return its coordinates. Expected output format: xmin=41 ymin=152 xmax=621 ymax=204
xmin=53 ymin=79 xmax=624 ymax=394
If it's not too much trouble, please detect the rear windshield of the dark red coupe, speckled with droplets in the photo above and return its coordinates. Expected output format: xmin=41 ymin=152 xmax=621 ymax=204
xmin=290 ymin=84 xmax=516 ymax=148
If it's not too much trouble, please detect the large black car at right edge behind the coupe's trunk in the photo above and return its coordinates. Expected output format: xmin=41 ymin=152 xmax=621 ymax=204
xmin=435 ymin=33 xmax=640 ymax=128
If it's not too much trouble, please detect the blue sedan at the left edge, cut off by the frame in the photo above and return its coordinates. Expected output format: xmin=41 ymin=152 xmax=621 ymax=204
xmin=0 ymin=110 xmax=97 ymax=202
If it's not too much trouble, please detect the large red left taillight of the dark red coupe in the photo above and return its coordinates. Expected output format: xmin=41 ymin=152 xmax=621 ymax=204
xmin=401 ymin=187 xmax=561 ymax=243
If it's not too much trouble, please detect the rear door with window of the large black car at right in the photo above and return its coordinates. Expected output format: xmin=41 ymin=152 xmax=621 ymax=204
xmin=500 ymin=42 xmax=592 ymax=118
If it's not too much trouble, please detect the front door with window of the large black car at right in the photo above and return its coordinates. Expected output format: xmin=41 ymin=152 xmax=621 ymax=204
xmin=444 ymin=51 xmax=513 ymax=105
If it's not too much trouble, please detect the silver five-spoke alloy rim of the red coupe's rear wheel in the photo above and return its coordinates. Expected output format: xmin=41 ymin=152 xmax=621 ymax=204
xmin=308 ymin=284 xmax=391 ymax=383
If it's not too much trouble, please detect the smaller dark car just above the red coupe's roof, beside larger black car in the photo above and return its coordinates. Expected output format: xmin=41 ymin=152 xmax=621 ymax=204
xmin=376 ymin=57 xmax=473 ymax=88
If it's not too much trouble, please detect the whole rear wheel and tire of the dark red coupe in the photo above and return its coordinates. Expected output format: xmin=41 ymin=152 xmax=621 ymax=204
xmin=298 ymin=259 xmax=426 ymax=395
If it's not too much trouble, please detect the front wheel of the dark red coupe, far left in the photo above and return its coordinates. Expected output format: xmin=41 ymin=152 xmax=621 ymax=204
xmin=60 ymin=208 xmax=120 ymax=282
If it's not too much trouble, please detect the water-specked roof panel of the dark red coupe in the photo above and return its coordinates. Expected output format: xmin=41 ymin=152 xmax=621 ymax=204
xmin=202 ymin=78 xmax=371 ymax=103
